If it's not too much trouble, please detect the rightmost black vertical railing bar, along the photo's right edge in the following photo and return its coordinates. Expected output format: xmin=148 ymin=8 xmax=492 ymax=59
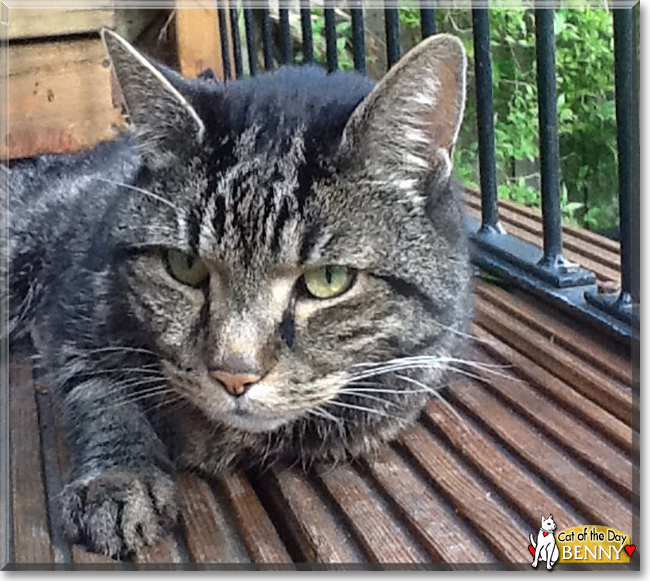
xmin=612 ymin=8 xmax=635 ymax=301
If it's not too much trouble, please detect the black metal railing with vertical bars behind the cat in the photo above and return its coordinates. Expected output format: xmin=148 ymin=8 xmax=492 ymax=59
xmin=218 ymin=0 xmax=639 ymax=342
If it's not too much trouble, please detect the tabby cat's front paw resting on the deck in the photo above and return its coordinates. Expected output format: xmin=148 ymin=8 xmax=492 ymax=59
xmin=59 ymin=468 xmax=178 ymax=558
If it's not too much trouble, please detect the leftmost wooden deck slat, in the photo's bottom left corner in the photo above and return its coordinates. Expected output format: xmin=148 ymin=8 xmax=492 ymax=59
xmin=9 ymin=361 xmax=54 ymax=563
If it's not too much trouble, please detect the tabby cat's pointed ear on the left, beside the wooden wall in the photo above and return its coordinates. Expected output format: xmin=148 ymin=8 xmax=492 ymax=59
xmin=101 ymin=28 xmax=205 ymax=169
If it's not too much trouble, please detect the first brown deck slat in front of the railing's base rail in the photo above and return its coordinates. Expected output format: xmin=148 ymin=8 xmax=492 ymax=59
xmin=474 ymin=281 xmax=632 ymax=386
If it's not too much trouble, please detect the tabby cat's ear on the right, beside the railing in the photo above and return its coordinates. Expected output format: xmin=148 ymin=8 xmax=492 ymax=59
xmin=342 ymin=34 xmax=467 ymax=202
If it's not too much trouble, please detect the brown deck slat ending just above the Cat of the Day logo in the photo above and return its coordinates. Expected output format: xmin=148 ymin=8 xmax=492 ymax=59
xmin=449 ymin=382 xmax=632 ymax=531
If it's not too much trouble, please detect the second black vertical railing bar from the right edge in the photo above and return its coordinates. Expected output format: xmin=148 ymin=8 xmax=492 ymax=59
xmin=535 ymin=8 xmax=563 ymax=269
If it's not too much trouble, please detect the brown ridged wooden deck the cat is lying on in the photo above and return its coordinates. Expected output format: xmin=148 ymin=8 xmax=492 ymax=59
xmin=3 ymin=203 xmax=639 ymax=569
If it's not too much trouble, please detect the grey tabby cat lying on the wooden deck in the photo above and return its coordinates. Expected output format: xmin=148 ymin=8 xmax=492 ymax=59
xmin=5 ymin=30 xmax=471 ymax=558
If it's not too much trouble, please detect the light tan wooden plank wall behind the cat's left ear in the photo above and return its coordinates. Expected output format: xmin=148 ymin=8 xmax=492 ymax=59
xmin=0 ymin=8 xmax=167 ymax=159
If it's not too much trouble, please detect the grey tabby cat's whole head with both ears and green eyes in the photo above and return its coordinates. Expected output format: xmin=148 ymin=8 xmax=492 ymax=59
xmin=103 ymin=31 xmax=470 ymax=440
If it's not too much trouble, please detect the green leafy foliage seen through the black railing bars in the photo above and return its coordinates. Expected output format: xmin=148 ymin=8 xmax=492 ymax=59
xmin=298 ymin=8 xmax=618 ymax=230
